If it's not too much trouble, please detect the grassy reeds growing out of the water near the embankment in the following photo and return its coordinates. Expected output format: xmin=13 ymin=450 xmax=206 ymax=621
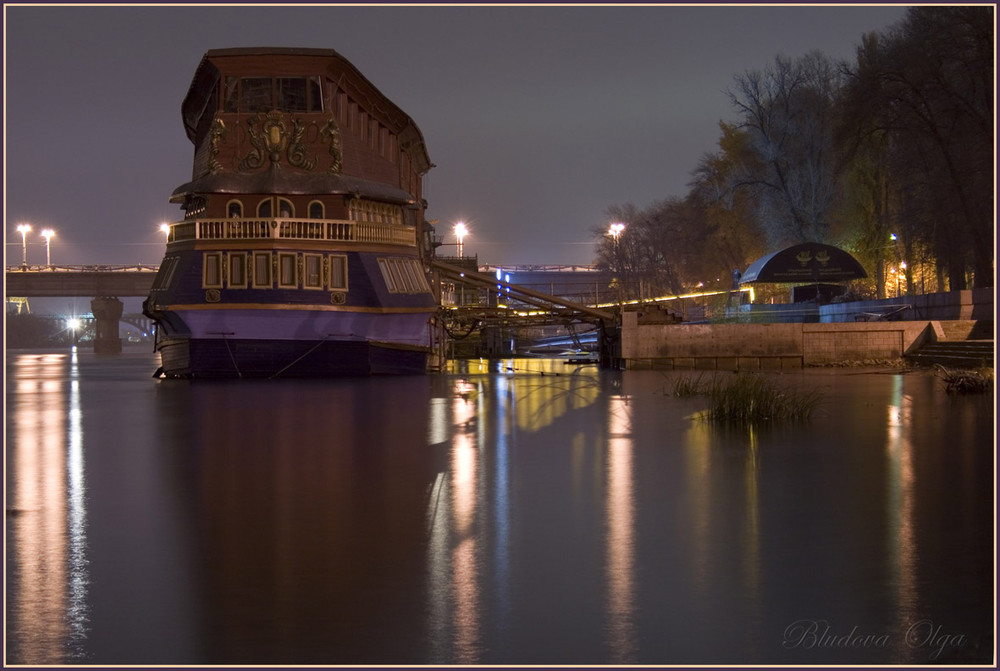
xmin=673 ymin=373 xmax=822 ymax=424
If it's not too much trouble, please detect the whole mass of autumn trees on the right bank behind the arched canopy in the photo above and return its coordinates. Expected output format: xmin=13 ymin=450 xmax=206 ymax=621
xmin=594 ymin=6 xmax=996 ymax=297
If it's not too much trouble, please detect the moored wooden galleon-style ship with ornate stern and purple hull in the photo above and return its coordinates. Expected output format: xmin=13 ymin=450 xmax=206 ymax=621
xmin=143 ymin=48 xmax=438 ymax=378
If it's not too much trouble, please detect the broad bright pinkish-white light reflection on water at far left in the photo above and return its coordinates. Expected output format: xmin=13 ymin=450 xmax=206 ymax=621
xmin=7 ymin=349 xmax=88 ymax=664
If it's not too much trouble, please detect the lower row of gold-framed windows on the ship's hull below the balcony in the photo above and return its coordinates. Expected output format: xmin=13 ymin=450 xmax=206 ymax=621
xmin=195 ymin=251 xmax=430 ymax=294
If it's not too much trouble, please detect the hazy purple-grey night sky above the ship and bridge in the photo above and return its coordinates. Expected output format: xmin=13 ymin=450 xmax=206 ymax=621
xmin=4 ymin=4 xmax=905 ymax=265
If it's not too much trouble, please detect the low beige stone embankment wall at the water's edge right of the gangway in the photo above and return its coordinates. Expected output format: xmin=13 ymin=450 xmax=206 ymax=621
xmin=622 ymin=312 xmax=956 ymax=370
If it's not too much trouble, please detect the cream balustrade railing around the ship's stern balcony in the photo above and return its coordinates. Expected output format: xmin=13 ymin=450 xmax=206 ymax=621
xmin=167 ymin=219 xmax=417 ymax=247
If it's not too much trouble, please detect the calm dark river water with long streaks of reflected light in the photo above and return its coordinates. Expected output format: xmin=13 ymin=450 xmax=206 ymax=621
xmin=6 ymin=350 xmax=995 ymax=665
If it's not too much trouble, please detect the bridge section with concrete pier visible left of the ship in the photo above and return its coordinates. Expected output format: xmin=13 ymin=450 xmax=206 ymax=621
xmin=4 ymin=265 xmax=158 ymax=354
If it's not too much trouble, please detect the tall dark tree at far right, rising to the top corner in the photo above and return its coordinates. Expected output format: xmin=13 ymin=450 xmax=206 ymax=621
xmin=841 ymin=6 xmax=995 ymax=289
